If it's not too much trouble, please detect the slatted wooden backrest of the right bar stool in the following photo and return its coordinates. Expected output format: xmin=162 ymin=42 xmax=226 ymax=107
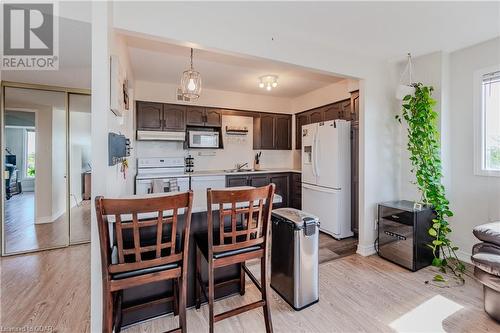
xmin=207 ymin=184 xmax=275 ymax=253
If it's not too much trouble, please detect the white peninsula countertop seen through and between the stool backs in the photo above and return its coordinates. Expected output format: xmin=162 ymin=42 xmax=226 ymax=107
xmin=108 ymin=186 xmax=283 ymax=223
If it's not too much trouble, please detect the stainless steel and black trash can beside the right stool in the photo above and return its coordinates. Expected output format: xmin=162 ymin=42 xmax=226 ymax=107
xmin=271 ymin=208 xmax=319 ymax=310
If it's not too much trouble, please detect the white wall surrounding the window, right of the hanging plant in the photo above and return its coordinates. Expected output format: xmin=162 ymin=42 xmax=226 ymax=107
xmin=449 ymin=38 xmax=500 ymax=258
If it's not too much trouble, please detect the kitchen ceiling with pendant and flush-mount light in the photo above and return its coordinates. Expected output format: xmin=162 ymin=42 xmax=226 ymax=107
xmin=125 ymin=36 xmax=343 ymax=98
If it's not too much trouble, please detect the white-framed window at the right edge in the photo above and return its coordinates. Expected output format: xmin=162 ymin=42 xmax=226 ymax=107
xmin=475 ymin=66 xmax=500 ymax=176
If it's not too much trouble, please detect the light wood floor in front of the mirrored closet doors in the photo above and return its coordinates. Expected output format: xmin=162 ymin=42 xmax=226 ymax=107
xmin=0 ymin=244 xmax=90 ymax=333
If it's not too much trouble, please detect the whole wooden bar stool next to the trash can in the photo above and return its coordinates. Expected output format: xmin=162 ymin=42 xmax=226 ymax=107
xmin=195 ymin=184 xmax=275 ymax=333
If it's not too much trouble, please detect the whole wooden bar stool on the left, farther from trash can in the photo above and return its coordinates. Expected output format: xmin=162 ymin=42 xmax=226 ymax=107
xmin=95 ymin=191 xmax=193 ymax=333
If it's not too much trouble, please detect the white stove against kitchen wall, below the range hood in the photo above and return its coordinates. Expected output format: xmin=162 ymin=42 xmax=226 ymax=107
xmin=135 ymin=157 xmax=189 ymax=194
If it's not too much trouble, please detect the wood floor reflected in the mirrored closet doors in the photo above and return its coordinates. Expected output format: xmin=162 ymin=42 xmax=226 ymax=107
xmin=5 ymin=192 xmax=90 ymax=253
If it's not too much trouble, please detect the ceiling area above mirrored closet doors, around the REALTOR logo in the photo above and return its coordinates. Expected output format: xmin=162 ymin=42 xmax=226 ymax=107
xmin=1 ymin=2 xmax=92 ymax=89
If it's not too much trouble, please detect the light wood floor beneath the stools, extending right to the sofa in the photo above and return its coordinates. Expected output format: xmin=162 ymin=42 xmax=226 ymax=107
xmin=123 ymin=254 xmax=500 ymax=333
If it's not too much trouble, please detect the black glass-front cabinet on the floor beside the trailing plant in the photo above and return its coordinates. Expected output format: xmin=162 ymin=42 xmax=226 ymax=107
xmin=378 ymin=200 xmax=435 ymax=271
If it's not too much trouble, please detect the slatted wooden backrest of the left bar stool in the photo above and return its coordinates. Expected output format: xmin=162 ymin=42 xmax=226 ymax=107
xmin=96 ymin=191 xmax=193 ymax=274
